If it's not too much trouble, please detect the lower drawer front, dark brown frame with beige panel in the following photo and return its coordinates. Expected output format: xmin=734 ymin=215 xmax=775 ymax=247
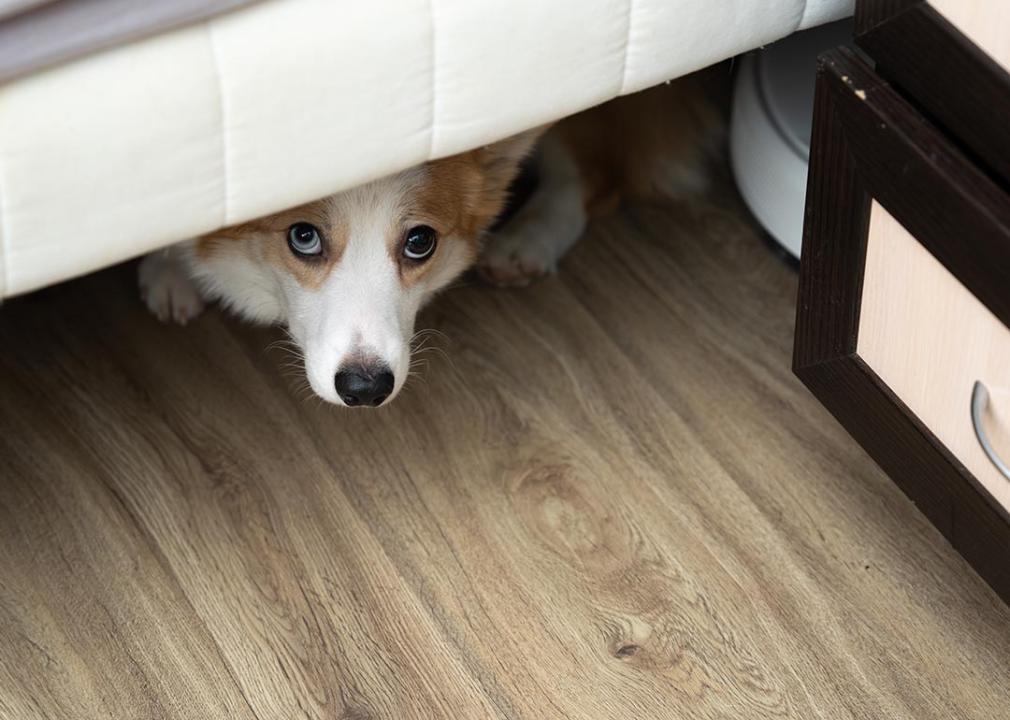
xmin=793 ymin=49 xmax=1010 ymax=602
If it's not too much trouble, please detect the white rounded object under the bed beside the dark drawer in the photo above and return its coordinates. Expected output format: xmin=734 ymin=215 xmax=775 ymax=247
xmin=729 ymin=21 xmax=852 ymax=258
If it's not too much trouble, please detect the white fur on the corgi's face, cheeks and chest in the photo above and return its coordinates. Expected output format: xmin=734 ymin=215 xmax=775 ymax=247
xmin=141 ymin=168 xmax=469 ymax=405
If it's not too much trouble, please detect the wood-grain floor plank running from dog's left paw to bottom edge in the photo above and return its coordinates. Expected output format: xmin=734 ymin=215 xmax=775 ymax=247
xmin=0 ymin=282 xmax=501 ymax=718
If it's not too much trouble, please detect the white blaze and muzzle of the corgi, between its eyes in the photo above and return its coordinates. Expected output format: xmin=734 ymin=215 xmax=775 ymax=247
xmin=291 ymin=170 xmax=422 ymax=402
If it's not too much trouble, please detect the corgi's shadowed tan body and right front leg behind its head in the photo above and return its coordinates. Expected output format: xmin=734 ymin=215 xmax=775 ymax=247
xmin=478 ymin=68 xmax=729 ymax=287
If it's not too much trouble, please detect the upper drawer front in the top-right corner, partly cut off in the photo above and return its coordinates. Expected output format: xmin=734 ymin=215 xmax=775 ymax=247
xmin=855 ymin=0 xmax=1010 ymax=183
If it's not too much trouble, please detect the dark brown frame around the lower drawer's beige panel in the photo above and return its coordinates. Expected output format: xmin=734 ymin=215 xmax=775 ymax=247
xmin=793 ymin=48 xmax=1010 ymax=603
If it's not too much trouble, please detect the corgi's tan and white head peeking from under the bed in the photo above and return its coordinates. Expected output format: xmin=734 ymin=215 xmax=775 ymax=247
xmin=185 ymin=130 xmax=539 ymax=407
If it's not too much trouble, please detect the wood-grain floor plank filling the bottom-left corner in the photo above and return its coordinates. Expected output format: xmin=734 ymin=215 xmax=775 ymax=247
xmin=0 ymin=349 xmax=255 ymax=720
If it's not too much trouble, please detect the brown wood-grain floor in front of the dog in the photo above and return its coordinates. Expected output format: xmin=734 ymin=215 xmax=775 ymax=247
xmin=0 ymin=186 xmax=1010 ymax=720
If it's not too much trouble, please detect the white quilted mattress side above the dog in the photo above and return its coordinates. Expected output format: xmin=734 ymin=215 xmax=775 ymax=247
xmin=0 ymin=0 xmax=852 ymax=297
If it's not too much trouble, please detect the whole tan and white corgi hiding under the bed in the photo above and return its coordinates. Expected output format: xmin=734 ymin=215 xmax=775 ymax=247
xmin=138 ymin=76 xmax=721 ymax=407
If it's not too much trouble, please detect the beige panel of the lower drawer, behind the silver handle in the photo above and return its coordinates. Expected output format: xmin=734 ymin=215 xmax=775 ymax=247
xmin=857 ymin=202 xmax=1010 ymax=509
